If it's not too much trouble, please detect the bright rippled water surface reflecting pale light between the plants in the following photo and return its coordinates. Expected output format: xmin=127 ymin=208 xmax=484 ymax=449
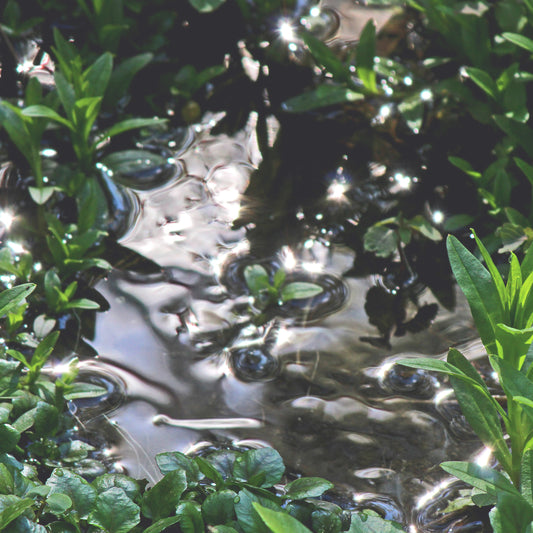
xmin=80 ymin=108 xmax=482 ymax=531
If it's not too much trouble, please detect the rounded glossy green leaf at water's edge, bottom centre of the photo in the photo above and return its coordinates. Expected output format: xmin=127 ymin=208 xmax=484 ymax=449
xmin=233 ymin=448 xmax=285 ymax=488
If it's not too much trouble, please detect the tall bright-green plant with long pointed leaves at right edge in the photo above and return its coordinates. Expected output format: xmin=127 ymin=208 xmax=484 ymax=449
xmin=399 ymin=233 xmax=533 ymax=533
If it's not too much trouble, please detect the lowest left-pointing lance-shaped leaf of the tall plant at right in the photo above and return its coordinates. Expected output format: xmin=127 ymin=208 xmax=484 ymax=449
xmin=440 ymin=461 xmax=522 ymax=498
